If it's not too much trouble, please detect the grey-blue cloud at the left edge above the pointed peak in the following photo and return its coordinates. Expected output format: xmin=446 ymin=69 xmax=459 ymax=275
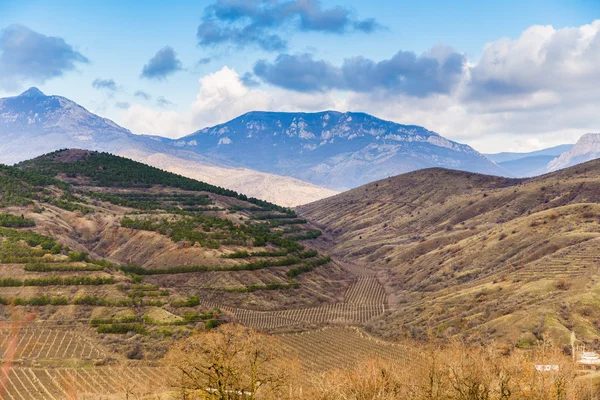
xmin=0 ymin=25 xmax=89 ymax=89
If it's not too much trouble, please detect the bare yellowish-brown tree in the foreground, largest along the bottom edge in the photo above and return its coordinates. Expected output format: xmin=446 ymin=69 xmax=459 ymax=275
xmin=167 ymin=324 xmax=293 ymax=400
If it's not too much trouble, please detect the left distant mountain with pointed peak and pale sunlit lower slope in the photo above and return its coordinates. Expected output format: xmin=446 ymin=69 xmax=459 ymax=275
xmin=0 ymin=88 xmax=335 ymax=206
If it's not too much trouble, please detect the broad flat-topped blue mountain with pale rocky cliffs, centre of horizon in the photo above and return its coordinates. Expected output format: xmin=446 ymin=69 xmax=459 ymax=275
xmin=171 ymin=111 xmax=509 ymax=189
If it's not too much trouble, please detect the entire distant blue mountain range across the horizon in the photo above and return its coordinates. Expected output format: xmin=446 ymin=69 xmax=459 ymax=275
xmin=0 ymin=88 xmax=600 ymax=206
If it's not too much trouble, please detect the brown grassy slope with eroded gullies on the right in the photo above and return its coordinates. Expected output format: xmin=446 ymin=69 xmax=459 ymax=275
xmin=299 ymin=161 xmax=600 ymax=345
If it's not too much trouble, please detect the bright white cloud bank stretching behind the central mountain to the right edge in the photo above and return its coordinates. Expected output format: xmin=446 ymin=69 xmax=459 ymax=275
xmin=120 ymin=20 xmax=600 ymax=152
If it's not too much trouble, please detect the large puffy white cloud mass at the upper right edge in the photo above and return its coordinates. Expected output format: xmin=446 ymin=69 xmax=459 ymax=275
xmin=466 ymin=20 xmax=600 ymax=110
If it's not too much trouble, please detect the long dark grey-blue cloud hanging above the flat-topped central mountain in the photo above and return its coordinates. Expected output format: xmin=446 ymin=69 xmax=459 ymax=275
xmin=254 ymin=49 xmax=467 ymax=96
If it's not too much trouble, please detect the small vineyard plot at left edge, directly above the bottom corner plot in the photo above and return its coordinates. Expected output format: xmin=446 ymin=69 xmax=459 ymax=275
xmin=0 ymin=329 xmax=106 ymax=360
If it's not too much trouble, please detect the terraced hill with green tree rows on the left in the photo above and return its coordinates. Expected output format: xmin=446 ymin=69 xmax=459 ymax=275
xmin=0 ymin=150 xmax=348 ymax=354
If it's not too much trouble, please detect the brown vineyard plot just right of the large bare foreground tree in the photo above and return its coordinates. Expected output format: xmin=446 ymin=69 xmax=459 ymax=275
xmin=279 ymin=327 xmax=412 ymax=372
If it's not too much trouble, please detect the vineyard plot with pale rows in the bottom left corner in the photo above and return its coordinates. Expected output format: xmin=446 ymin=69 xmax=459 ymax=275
xmin=0 ymin=367 xmax=171 ymax=400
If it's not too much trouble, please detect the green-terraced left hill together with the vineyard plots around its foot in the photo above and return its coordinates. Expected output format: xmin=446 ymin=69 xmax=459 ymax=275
xmin=0 ymin=150 xmax=408 ymax=400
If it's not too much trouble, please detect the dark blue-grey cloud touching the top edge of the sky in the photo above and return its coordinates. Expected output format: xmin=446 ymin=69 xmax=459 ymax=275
xmin=197 ymin=0 xmax=380 ymax=51
